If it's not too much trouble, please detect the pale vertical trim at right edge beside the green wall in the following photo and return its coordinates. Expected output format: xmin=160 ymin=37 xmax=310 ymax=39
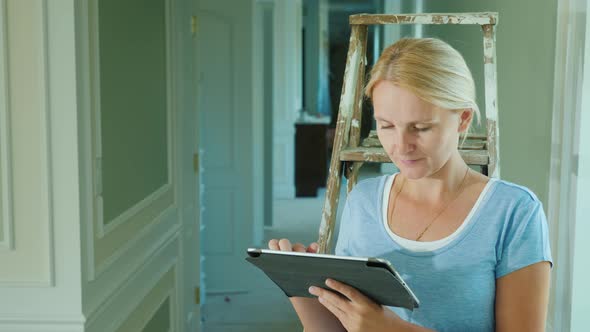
xmin=547 ymin=0 xmax=587 ymax=331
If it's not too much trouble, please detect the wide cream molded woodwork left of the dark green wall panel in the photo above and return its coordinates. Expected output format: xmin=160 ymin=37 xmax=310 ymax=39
xmin=0 ymin=0 xmax=85 ymax=324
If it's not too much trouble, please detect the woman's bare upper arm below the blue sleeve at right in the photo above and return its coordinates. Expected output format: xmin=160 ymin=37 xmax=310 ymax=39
xmin=496 ymin=262 xmax=550 ymax=332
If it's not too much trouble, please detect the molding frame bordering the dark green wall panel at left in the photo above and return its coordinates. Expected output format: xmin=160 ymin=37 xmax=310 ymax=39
xmin=78 ymin=0 xmax=179 ymax=281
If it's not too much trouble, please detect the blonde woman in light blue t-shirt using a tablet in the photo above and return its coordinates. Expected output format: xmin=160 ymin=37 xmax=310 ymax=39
xmin=269 ymin=38 xmax=552 ymax=332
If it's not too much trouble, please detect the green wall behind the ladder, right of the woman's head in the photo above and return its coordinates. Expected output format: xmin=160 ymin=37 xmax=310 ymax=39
xmin=424 ymin=0 xmax=557 ymax=210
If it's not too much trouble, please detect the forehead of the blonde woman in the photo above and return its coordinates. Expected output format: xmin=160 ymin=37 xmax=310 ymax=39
xmin=372 ymin=81 xmax=441 ymax=122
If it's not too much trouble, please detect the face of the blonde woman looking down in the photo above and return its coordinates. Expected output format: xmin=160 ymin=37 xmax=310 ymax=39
xmin=372 ymin=81 xmax=464 ymax=179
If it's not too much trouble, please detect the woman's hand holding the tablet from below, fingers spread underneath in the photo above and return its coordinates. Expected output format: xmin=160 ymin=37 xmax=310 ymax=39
xmin=309 ymin=279 xmax=403 ymax=332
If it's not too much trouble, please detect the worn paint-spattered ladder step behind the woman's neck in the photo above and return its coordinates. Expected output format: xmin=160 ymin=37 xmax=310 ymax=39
xmin=340 ymin=147 xmax=490 ymax=166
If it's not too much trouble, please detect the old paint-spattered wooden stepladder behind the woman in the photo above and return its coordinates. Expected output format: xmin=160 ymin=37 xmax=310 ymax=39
xmin=318 ymin=13 xmax=500 ymax=253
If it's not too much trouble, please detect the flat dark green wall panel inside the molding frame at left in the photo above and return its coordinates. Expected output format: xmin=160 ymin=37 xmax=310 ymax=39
xmin=99 ymin=0 xmax=168 ymax=223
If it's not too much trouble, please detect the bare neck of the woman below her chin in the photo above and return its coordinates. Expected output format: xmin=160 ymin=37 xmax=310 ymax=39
xmin=403 ymin=151 xmax=469 ymax=204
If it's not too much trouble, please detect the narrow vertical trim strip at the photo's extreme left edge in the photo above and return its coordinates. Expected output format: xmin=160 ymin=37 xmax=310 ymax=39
xmin=0 ymin=0 xmax=14 ymax=250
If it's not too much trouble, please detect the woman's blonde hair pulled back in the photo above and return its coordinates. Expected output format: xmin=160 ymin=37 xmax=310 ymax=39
xmin=365 ymin=38 xmax=480 ymax=138
